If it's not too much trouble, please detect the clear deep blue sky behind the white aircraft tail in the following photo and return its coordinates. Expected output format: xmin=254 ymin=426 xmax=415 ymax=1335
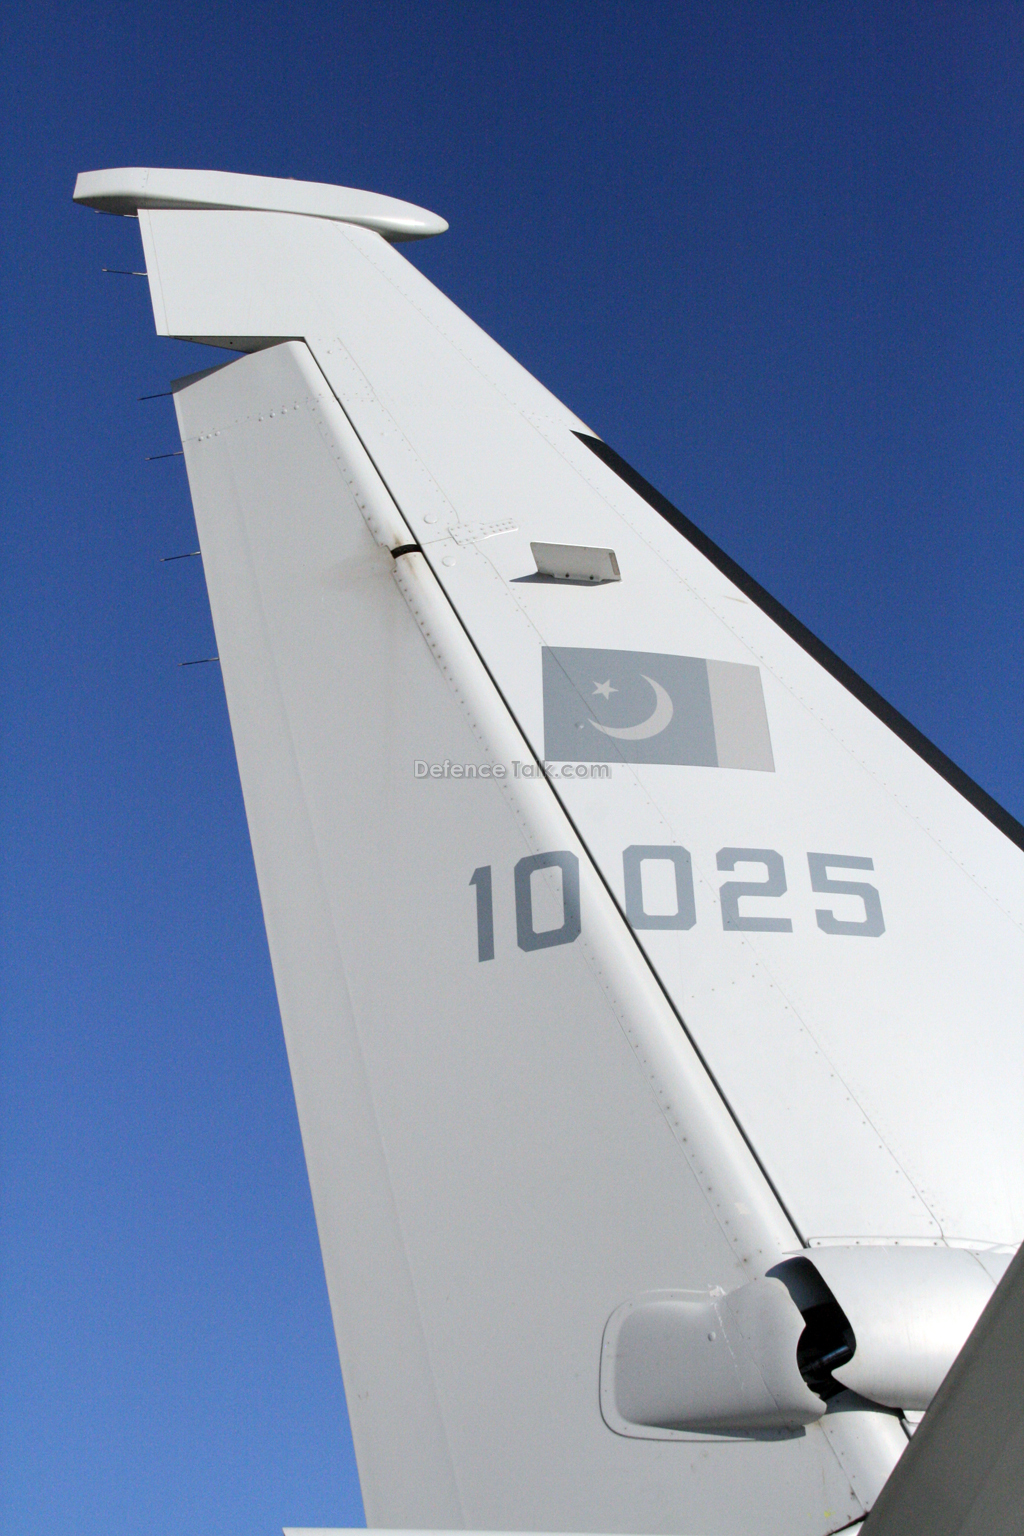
xmin=0 ymin=9 xmax=1024 ymax=1536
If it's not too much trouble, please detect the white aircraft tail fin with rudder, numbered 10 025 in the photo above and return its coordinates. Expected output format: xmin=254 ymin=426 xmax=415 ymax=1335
xmin=82 ymin=172 xmax=1024 ymax=1536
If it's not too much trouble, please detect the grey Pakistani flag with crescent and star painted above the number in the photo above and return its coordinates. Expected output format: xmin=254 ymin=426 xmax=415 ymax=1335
xmin=542 ymin=645 xmax=775 ymax=773
